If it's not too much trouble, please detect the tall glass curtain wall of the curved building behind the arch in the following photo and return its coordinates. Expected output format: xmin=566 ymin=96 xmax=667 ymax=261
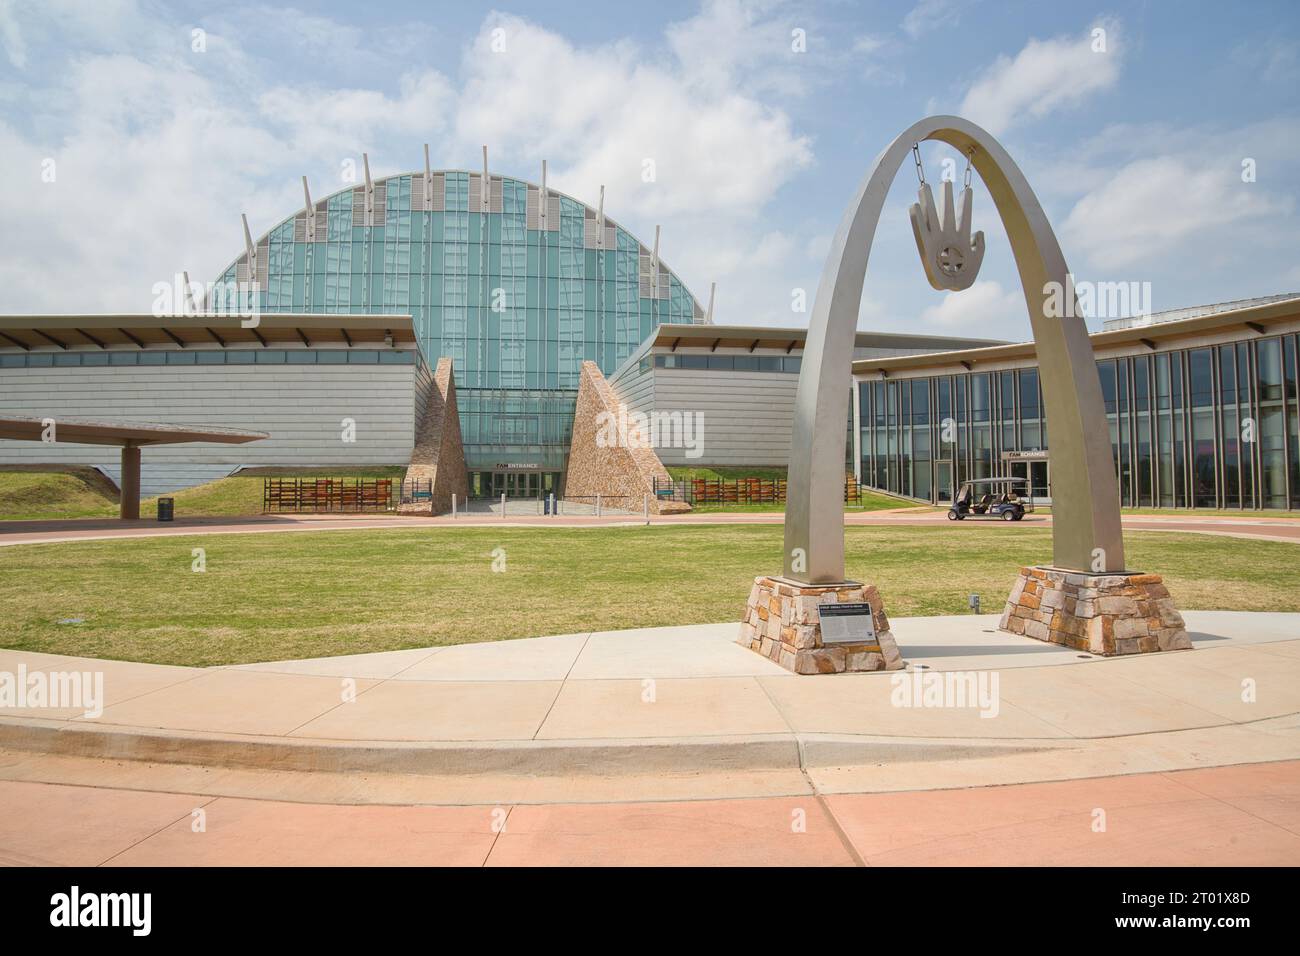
xmin=858 ymin=334 xmax=1300 ymax=510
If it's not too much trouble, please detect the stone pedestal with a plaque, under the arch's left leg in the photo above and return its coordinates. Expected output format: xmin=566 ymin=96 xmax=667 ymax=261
xmin=736 ymin=576 xmax=904 ymax=674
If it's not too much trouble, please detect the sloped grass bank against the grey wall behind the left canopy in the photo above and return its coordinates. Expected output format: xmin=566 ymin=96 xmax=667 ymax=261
xmin=0 ymin=466 xmax=406 ymax=520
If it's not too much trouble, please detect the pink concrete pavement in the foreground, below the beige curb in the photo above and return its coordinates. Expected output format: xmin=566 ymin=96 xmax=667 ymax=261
xmin=0 ymin=761 xmax=1300 ymax=866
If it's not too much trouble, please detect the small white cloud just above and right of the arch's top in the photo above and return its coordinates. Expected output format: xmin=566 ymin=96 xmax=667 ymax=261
xmin=959 ymin=21 xmax=1123 ymax=134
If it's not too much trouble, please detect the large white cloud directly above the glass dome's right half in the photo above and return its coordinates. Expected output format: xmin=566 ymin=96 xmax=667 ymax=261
xmin=456 ymin=16 xmax=813 ymax=217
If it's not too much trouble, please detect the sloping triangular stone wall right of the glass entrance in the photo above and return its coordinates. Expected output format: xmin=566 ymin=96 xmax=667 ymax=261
xmin=564 ymin=362 xmax=690 ymax=514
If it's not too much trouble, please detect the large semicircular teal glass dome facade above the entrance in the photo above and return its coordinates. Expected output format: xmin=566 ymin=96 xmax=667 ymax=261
xmin=218 ymin=170 xmax=703 ymax=389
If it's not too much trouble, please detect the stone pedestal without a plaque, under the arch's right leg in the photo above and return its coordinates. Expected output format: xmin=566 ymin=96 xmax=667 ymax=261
xmin=998 ymin=567 xmax=1192 ymax=657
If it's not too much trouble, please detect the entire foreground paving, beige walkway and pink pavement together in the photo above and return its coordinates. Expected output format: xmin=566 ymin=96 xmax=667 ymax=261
xmin=0 ymin=611 xmax=1300 ymax=865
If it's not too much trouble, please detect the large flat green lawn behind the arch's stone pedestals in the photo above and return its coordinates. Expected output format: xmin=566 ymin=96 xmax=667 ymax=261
xmin=0 ymin=524 xmax=1300 ymax=665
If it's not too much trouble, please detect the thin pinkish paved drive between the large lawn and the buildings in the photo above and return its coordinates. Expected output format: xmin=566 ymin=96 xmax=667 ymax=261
xmin=0 ymin=507 xmax=1300 ymax=546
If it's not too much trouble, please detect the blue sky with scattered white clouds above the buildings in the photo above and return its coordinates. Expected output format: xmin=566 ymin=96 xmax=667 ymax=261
xmin=0 ymin=0 xmax=1300 ymax=341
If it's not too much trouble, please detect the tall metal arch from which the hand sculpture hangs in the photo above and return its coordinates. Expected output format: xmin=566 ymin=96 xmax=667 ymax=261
xmin=784 ymin=116 xmax=1125 ymax=584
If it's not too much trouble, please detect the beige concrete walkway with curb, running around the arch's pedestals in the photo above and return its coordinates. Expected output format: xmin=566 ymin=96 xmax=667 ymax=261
xmin=0 ymin=611 xmax=1300 ymax=803
